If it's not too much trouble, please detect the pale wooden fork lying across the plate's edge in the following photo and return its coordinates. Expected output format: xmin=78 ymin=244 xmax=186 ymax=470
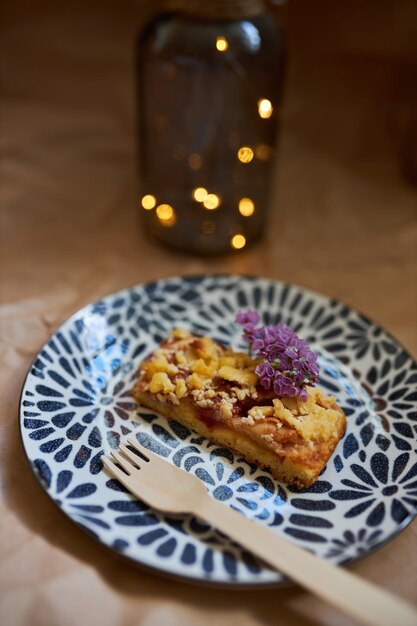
xmin=101 ymin=439 xmax=417 ymax=626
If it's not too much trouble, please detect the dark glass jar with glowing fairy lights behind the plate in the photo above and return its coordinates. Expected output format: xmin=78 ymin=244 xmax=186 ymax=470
xmin=138 ymin=0 xmax=284 ymax=254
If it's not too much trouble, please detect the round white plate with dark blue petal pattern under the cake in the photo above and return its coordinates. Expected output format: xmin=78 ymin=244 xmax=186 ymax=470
xmin=20 ymin=276 xmax=417 ymax=585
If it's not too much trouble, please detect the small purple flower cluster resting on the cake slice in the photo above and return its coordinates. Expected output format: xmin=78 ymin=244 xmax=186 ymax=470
xmin=236 ymin=311 xmax=319 ymax=401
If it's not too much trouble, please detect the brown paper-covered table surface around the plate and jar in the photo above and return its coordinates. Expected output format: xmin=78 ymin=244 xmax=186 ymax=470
xmin=0 ymin=0 xmax=417 ymax=626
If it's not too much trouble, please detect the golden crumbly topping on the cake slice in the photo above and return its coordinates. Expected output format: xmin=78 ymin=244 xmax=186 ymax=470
xmin=136 ymin=329 xmax=341 ymax=443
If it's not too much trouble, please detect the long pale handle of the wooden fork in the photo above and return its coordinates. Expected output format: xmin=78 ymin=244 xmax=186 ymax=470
xmin=194 ymin=497 xmax=417 ymax=626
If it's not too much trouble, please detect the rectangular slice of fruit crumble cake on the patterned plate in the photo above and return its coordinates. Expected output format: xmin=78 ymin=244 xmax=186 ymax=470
xmin=133 ymin=330 xmax=346 ymax=488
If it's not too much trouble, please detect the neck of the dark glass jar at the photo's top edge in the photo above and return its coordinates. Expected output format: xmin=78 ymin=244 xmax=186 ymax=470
xmin=154 ymin=0 xmax=265 ymax=21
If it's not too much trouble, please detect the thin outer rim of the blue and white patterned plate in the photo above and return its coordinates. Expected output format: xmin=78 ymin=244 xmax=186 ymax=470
xmin=17 ymin=272 xmax=417 ymax=591
